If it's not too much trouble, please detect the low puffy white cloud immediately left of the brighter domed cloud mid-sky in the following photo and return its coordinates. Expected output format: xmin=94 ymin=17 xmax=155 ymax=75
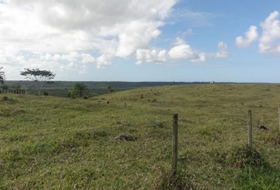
xmin=136 ymin=49 xmax=166 ymax=65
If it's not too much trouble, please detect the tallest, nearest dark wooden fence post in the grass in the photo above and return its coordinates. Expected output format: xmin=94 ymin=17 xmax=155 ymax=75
xmin=172 ymin=113 xmax=178 ymax=175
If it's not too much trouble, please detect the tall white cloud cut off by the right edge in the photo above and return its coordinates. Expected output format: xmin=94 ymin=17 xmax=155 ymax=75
xmin=259 ymin=11 xmax=280 ymax=53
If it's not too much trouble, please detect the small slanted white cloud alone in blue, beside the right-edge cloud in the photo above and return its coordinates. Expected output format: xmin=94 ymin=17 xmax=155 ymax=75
xmin=235 ymin=26 xmax=258 ymax=48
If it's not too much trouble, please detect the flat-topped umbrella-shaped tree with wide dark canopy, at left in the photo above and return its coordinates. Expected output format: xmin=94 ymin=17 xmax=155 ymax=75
xmin=20 ymin=68 xmax=55 ymax=95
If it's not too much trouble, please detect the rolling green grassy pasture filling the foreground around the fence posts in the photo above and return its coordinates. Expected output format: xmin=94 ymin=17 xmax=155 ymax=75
xmin=0 ymin=84 xmax=280 ymax=190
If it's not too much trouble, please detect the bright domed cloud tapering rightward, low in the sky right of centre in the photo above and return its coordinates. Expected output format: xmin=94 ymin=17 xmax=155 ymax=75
xmin=168 ymin=44 xmax=205 ymax=62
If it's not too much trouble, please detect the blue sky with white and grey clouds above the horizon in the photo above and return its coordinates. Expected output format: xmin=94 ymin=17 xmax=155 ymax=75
xmin=0 ymin=0 xmax=280 ymax=82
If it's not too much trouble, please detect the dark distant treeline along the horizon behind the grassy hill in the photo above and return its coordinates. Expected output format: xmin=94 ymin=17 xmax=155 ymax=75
xmin=5 ymin=81 xmax=209 ymax=97
